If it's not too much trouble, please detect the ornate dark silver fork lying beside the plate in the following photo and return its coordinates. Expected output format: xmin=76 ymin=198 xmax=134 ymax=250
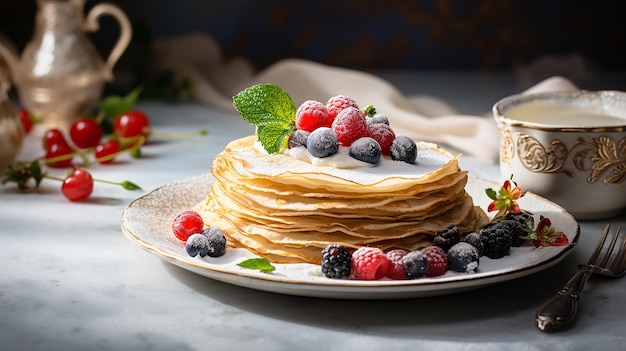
xmin=537 ymin=224 xmax=626 ymax=331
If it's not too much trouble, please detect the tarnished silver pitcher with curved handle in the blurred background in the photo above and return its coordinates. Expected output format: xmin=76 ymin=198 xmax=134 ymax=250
xmin=0 ymin=0 xmax=132 ymax=127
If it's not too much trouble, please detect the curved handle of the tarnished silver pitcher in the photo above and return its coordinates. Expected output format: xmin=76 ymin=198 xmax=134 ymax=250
xmin=84 ymin=4 xmax=132 ymax=81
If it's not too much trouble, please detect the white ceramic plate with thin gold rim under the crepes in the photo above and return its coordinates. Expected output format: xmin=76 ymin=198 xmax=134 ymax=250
xmin=121 ymin=174 xmax=580 ymax=299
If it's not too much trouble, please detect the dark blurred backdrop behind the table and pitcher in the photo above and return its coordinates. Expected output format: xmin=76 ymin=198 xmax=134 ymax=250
xmin=0 ymin=0 xmax=626 ymax=93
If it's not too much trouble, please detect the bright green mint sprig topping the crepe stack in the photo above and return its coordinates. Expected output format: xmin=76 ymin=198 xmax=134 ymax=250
xmin=233 ymin=84 xmax=296 ymax=154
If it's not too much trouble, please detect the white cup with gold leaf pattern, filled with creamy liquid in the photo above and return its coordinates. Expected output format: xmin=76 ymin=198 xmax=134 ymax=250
xmin=493 ymin=91 xmax=626 ymax=220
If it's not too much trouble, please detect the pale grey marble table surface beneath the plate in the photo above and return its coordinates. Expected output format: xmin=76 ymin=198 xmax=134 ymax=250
xmin=0 ymin=73 xmax=626 ymax=351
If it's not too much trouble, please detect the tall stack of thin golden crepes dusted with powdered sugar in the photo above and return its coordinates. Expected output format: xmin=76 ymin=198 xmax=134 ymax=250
xmin=196 ymin=136 xmax=487 ymax=264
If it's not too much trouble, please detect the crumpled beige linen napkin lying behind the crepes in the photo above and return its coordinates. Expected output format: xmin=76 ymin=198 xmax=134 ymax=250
xmin=155 ymin=34 xmax=577 ymax=163
